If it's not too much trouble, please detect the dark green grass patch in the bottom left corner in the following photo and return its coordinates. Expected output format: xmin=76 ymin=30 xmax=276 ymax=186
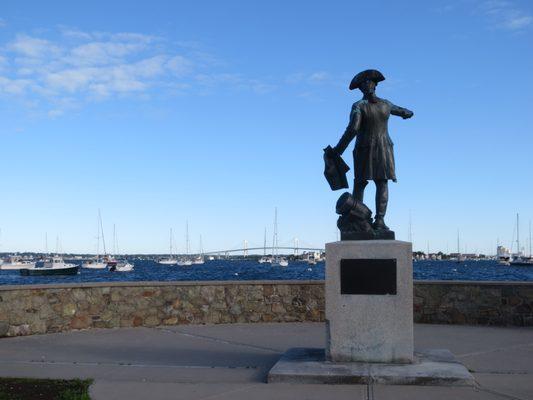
xmin=0 ymin=378 xmax=93 ymax=400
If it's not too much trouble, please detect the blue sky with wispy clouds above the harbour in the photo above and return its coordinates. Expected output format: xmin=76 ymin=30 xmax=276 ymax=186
xmin=0 ymin=0 xmax=533 ymax=252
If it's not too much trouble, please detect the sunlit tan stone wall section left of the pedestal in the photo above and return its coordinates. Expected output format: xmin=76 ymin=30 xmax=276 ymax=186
xmin=0 ymin=281 xmax=324 ymax=337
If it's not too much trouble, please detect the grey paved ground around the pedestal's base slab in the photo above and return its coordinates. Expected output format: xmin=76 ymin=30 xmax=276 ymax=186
xmin=0 ymin=323 xmax=533 ymax=400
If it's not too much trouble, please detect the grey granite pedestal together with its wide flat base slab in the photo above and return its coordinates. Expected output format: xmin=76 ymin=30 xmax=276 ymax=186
xmin=268 ymin=240 xmax=474 ymax=386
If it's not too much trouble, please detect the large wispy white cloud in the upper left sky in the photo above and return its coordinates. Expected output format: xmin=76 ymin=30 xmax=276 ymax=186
xmin=0 ymin=27 xmax=274 ymax=117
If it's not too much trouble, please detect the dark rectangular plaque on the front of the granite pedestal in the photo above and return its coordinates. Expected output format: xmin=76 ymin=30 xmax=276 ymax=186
xmin=341 ymin=258 xmax=396 ymax=295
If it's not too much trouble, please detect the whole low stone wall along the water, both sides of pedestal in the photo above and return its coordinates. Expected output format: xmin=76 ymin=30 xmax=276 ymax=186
xmin=0 ymin=281 xmax=533 ymax=337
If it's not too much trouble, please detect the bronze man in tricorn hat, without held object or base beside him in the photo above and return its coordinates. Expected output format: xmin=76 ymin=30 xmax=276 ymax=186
xmin=334 ymin=69 xmax=413 ymax=231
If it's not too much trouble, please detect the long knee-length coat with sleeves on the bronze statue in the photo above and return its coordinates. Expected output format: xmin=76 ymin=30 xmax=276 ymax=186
xmin=335 ymin=98 xmax=411 ymax=182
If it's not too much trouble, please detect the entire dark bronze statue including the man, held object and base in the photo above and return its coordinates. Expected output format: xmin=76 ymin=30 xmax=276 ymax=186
xmin=324 ymin=70 xmax=413 ymax=239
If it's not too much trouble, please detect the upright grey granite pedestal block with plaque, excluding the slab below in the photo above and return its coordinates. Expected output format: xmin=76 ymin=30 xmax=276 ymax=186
xmin=326 ymin=240 xmax=413 ymax=363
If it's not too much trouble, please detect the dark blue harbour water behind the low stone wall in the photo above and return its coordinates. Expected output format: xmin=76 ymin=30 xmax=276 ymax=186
xmin=0 ymin=260 xmax=533 ymax=285
